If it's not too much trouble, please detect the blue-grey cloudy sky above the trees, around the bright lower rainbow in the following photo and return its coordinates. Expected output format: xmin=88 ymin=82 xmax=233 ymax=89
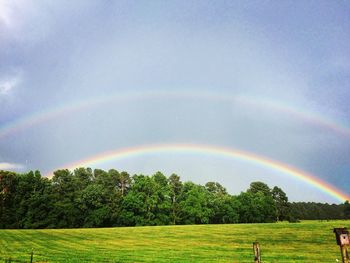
xmin=0 ymin=0 xmax=350 ymax=203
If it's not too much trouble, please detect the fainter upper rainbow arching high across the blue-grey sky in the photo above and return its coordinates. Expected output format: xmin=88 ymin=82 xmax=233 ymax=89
xmin=0 ymin=91 xmax=350 ymax=139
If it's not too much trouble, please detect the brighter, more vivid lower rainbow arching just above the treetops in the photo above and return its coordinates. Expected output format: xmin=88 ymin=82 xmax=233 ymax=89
xmin=46 ymin=144 xmax=350 ymax=202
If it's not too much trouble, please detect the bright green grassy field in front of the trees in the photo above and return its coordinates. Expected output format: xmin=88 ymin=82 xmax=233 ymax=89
xmin=0 ymin=221 xmax=350 ymax=263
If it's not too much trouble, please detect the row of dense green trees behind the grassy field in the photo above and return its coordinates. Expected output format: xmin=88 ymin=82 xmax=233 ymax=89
xmin=0 ymin=168 xmax=350 ymax=228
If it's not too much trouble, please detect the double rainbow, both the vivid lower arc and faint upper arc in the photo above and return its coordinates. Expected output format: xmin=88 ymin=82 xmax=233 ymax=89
xmin=0 ymin=91 xmax=350 ymax=201
